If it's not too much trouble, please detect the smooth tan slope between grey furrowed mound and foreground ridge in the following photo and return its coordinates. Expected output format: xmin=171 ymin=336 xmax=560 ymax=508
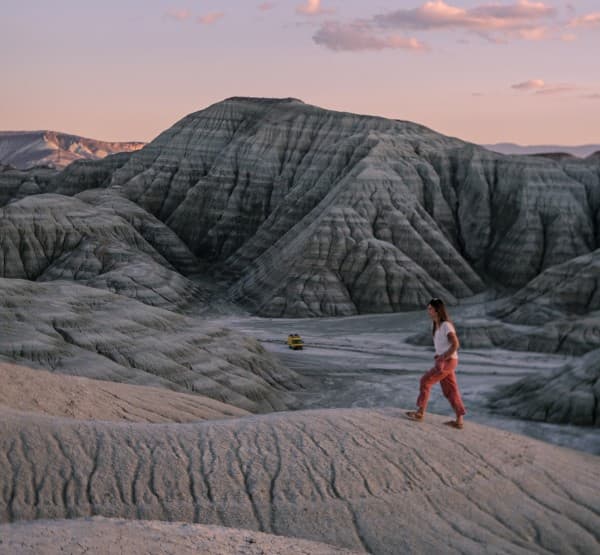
xmin=0 ymin=363 xmax=248 ymax=423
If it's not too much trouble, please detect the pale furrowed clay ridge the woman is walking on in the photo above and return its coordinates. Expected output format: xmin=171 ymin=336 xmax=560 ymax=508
xmin=0 ymin=409 xmax=600 ymax=554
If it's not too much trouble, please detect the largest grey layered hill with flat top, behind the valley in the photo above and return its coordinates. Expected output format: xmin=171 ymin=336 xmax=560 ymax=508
xmin=96 ymin=98 xmax=600 ymax=316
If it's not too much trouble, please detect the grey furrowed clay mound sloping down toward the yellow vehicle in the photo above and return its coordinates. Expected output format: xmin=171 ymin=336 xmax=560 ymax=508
xmin=0 ymin=278 xmax=301 ymax=412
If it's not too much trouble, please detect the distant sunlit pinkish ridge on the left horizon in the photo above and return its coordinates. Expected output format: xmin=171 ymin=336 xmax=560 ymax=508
xmin=0 ymin=130 xmax=145 ymax=170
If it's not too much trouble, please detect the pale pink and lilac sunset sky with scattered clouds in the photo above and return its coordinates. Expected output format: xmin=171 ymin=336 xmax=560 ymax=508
xmin=0 ymin=0 xmax=600 ymax=145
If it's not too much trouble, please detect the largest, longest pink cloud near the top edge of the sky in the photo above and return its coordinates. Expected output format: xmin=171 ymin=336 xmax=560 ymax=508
xmin=373 ymin=0 xmax=556 ymax=40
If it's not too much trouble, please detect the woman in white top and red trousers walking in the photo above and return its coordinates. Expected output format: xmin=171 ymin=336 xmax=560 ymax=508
xmin=406 ymin=299 xmax=466 ymax=430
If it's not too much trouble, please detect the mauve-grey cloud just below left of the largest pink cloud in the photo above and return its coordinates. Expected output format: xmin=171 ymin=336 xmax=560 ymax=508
xmin=313 ymin=21 xmax=428 ymax=52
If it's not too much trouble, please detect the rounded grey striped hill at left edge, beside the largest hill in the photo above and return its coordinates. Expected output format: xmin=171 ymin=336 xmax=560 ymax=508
xmin=0 ymin=191 xmax=202 ymax=308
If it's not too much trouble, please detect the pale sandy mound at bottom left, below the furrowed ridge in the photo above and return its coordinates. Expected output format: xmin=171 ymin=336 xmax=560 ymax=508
xmin=0 ymin=517 xmax=358 ymax=555
